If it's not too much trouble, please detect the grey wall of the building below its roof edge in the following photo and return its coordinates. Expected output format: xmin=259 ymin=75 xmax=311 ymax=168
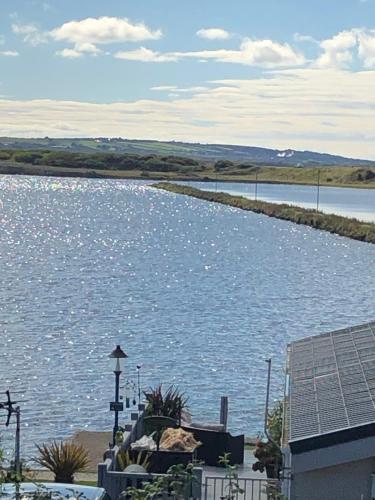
xmin=290 ymin=458 xmax=375 ymax=500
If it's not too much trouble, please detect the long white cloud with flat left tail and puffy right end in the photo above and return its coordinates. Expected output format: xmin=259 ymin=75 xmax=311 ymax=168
xmin=115 ymin=39 xmax=305 ymax=68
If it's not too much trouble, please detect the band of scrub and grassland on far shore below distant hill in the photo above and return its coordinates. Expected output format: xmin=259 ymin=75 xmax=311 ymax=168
xmin=0 ymin=150 xmax=375 ymax=189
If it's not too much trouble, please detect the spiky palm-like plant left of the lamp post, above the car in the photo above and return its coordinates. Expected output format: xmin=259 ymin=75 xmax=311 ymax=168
xmin=34 ymin=441 xmax=90 ymax=483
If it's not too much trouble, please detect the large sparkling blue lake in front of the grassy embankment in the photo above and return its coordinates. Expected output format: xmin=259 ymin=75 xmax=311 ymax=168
xmin=0 ymin=176 xmax=375 ymax=455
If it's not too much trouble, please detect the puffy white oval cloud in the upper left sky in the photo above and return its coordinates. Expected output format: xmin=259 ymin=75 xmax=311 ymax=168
xmin=50 ymin=17 xmax=162 ymax=44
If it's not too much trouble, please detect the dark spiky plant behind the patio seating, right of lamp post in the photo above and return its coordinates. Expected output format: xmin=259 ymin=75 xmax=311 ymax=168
xmin=144 ymin=384 xmax=188 ymax=420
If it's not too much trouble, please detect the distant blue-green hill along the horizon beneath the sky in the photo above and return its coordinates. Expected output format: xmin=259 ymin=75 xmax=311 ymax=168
xmin=0 ymin=137 xmax=375 ymax=167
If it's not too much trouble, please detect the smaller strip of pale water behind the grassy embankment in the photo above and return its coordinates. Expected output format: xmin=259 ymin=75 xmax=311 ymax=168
xmin=188 ymin=182 xmax=375 ymax=222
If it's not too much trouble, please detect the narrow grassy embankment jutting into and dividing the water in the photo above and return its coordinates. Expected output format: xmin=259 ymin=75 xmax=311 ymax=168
xmin=151 ymin=182 xmax=375 ymax=243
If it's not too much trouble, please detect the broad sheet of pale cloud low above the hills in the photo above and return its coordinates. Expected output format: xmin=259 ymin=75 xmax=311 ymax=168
xmin=0 ymin=68 xmax=375 ymax=159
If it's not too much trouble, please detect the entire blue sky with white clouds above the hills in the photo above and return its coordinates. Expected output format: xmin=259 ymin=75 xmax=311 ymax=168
xmin=0 ymin=0 xmax=375 ymax=159
